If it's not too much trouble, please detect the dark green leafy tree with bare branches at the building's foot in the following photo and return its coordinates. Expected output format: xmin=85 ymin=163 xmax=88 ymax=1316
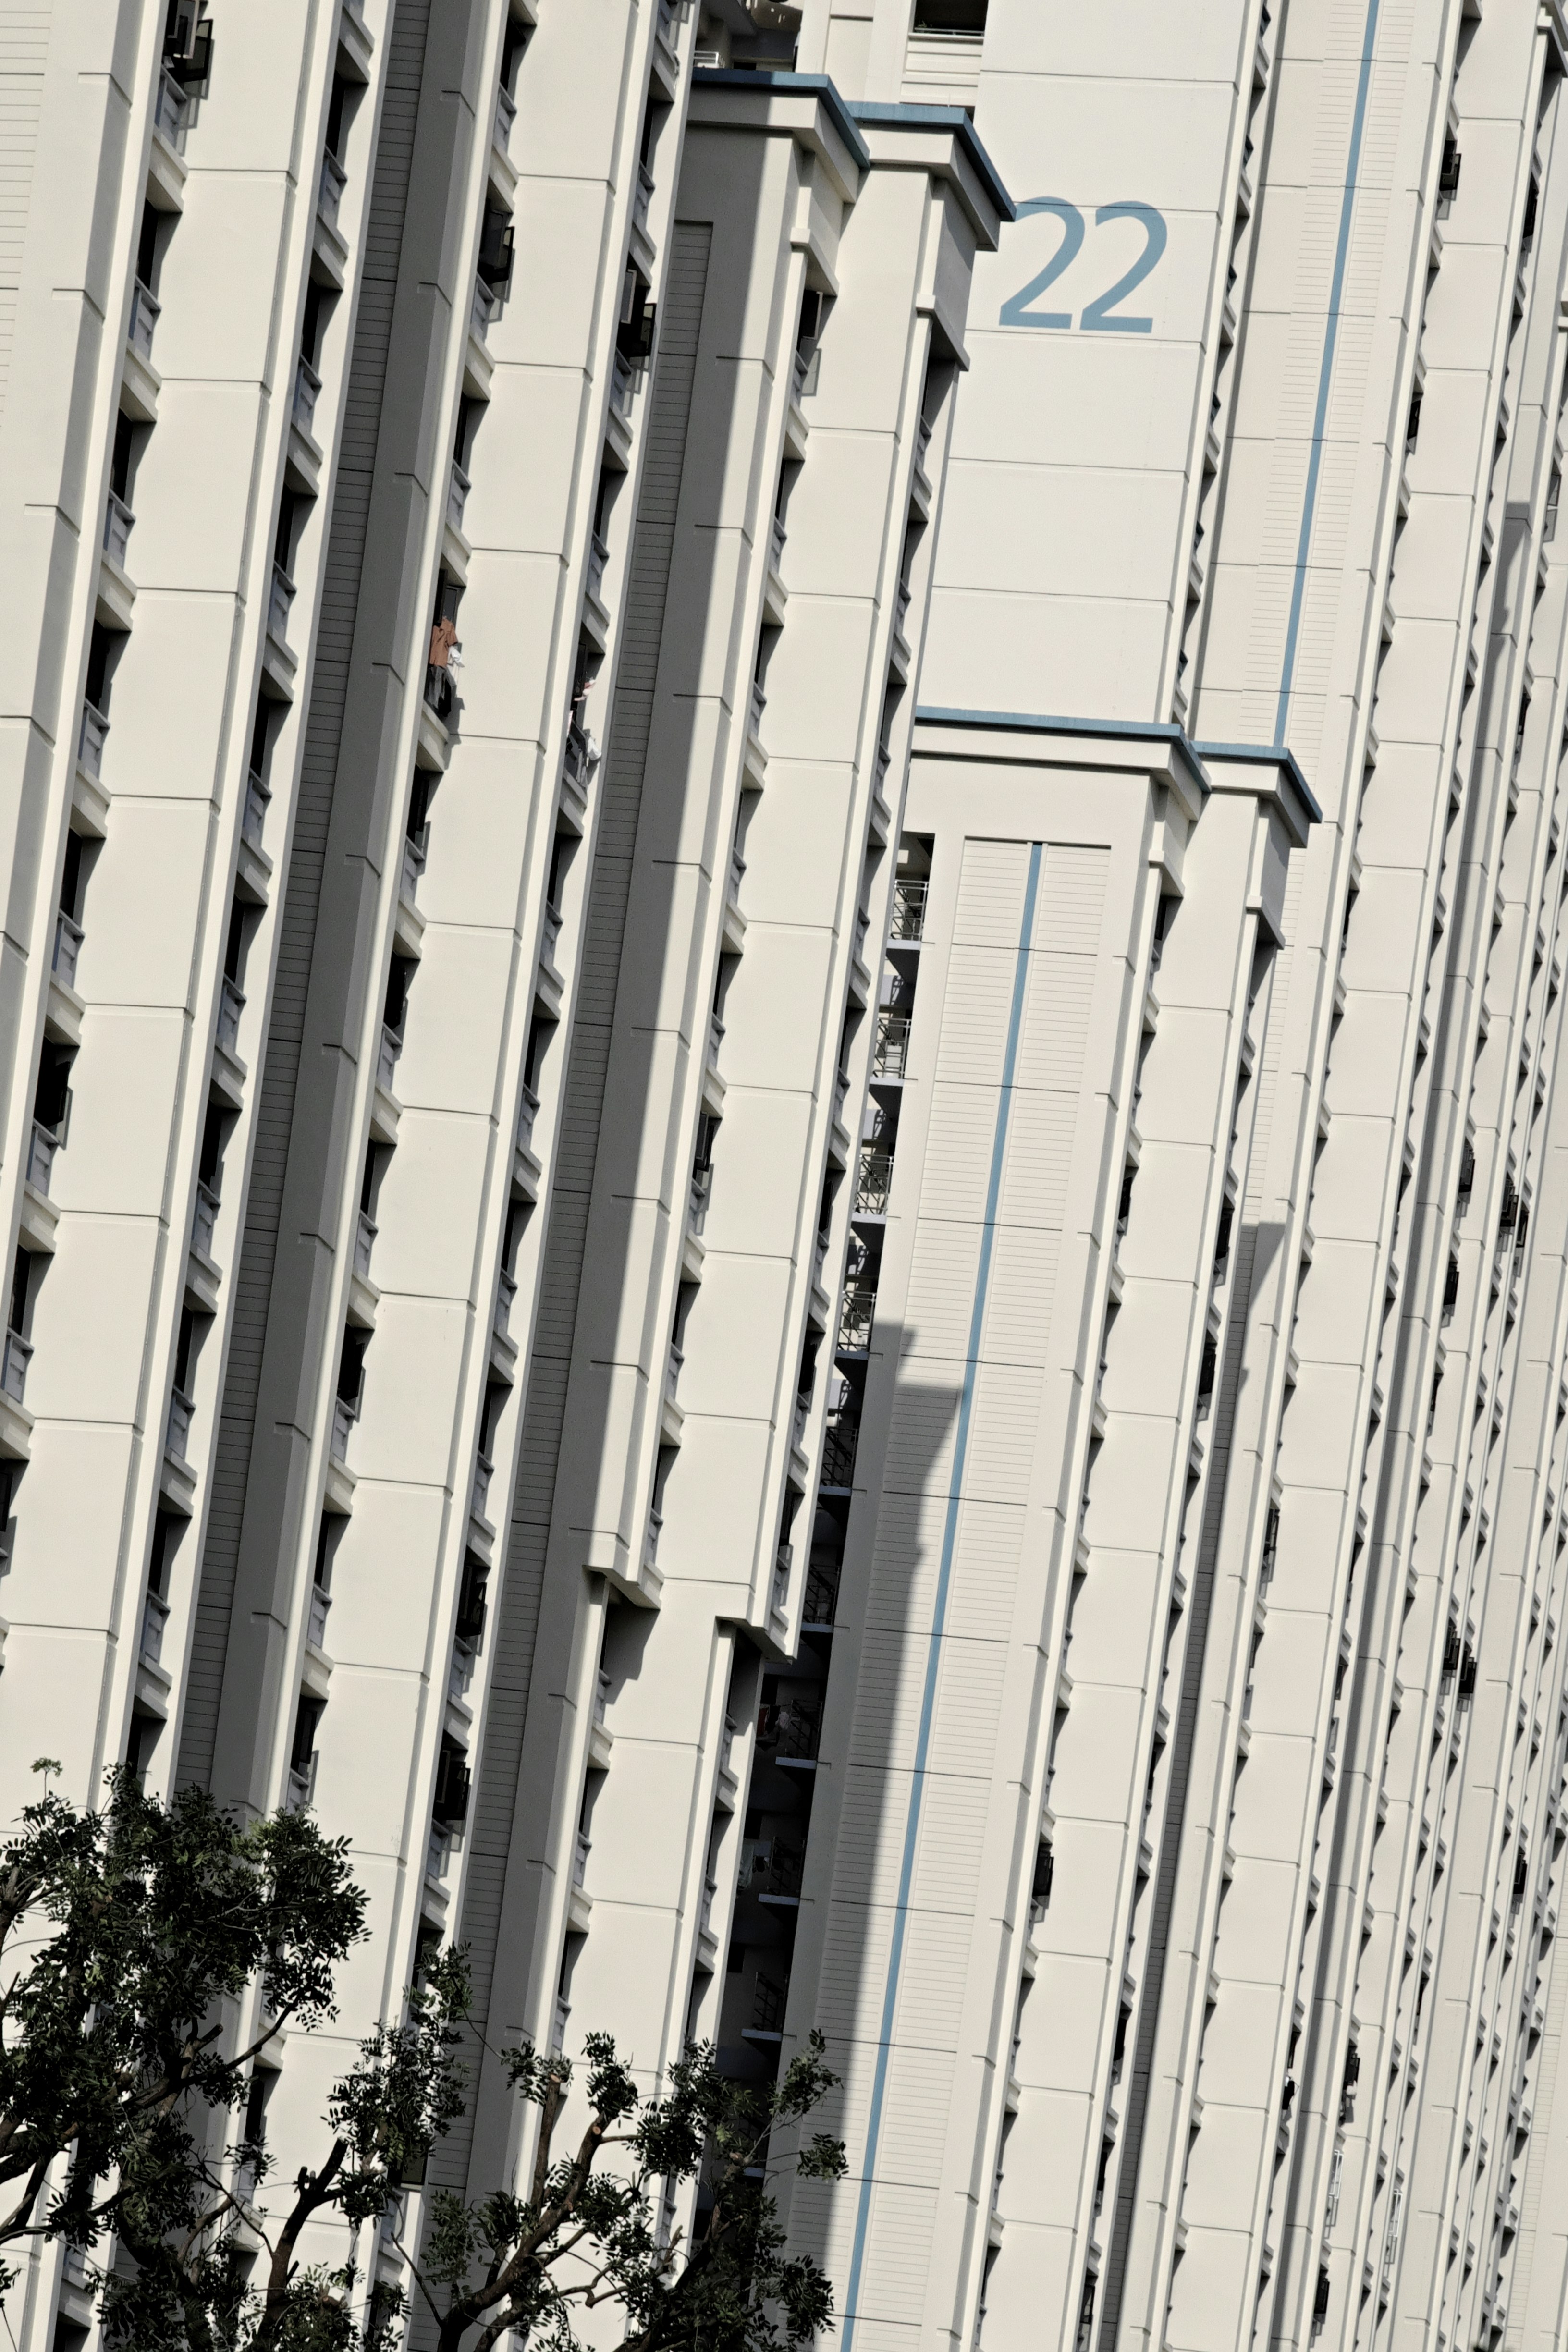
xmin=0 ymin=1771 xmax=844 ymax=2352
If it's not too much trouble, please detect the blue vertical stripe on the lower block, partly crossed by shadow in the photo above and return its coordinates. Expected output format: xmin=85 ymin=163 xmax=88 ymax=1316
xmin=844 ymin=842 xmax=1041 ymax=2352
